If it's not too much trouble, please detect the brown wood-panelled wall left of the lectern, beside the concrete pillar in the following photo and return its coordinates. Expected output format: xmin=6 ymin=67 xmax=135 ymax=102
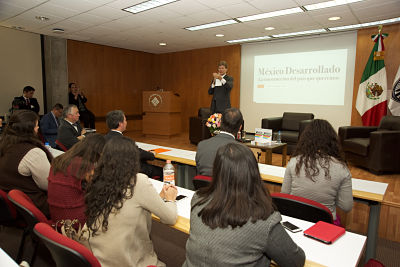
xmin=67 ymin=40 xmax=154 ymax=116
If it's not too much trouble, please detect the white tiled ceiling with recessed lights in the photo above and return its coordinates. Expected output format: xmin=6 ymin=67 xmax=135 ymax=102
xmin=0 ymin=0 xmax=400 ymax=53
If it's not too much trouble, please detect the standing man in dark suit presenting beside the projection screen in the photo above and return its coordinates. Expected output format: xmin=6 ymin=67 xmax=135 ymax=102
xmin=208 ymin=61 xmax=233 ymax=114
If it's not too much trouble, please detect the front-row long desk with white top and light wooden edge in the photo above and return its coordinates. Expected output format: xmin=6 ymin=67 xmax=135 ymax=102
xmin=138 ymin=142 xmax=388 ymax=261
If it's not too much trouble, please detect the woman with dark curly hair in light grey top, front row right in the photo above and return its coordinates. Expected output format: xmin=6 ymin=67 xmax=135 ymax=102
xmin=281 ymin=120 xmax=353 ymax=223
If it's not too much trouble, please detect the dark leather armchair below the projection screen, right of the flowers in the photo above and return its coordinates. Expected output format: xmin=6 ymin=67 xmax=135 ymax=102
xmin=261 ymin=112 xmax=314 ymax=155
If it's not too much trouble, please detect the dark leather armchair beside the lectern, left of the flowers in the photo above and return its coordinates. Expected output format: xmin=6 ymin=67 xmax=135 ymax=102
xmin=189 ymin=108 xmax=211 ymax=145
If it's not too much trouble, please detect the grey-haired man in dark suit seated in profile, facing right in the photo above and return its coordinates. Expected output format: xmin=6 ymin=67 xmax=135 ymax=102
xmin=57 ymin=105 xmax=86 ymax=149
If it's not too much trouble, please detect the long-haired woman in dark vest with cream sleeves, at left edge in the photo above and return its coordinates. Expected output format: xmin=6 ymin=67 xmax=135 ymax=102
xmin=0 ymin=110 xmax=53 ymax=216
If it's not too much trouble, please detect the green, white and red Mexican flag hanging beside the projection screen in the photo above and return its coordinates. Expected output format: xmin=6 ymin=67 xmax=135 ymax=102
xmin=356 ymin=32 xmax=387 ymax=126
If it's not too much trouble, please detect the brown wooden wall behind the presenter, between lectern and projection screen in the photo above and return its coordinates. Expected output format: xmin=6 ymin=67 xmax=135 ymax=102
xmin=153 ymin=45 xmax=241 ymax=131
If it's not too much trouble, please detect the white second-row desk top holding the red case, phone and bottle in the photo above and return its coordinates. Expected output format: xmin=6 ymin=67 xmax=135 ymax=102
xmin=151 ymin=179 xmax=366 ymax=267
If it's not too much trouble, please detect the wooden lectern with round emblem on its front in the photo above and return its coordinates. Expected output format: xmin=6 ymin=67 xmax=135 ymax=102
xmin=143 ymin=91 xmax=181 ymax=136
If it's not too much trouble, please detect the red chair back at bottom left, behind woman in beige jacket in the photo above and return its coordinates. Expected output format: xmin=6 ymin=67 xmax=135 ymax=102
xmin=33 ymin=223 xmax=101 ymax=267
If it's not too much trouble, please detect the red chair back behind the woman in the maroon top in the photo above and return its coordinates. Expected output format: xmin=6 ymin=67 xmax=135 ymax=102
xmin=8 ymin=189 xmax=51 ymax=229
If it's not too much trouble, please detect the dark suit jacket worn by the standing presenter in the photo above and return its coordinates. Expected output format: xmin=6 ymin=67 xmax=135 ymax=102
xmin=208 ymin=75 xmax=233 ymax=114
